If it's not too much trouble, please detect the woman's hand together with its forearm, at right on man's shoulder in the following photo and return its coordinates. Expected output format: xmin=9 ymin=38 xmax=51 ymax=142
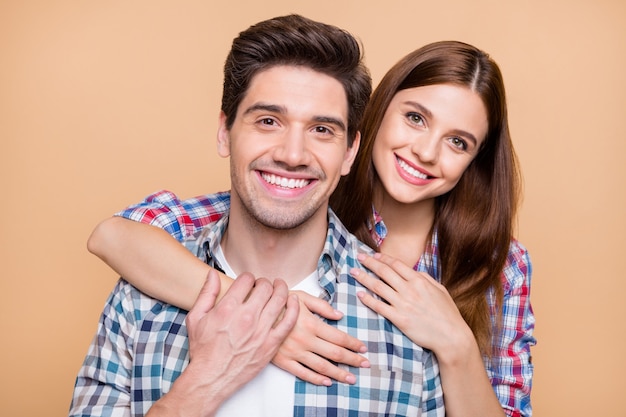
xmin=350 ymin=253 xmax=504 ymax=417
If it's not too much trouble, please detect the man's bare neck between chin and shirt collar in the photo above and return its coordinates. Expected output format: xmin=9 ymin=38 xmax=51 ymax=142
xmin=221 ymin=201 xmax=328 ymax=288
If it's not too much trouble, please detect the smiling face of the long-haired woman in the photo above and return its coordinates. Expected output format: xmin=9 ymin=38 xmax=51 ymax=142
xmin=372 ymin=84 xmax=488 ymax=204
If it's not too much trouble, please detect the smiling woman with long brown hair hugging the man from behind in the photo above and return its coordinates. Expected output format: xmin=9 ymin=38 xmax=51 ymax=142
xmin=89 ymin=42 xmax=535 ymax=416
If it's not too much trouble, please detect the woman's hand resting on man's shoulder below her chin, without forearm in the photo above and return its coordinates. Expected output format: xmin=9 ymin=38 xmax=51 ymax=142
xmin=350 ymin=253 xmax=471 ymax=357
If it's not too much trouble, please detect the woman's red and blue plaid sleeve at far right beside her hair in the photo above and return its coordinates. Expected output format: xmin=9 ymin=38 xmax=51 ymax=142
xmin=485 ymin=241 xmax=536 ymax=417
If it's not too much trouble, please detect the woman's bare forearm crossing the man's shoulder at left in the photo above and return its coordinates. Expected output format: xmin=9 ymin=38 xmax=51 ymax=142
xmin=87 ymin=217 xmax=232 ymax=310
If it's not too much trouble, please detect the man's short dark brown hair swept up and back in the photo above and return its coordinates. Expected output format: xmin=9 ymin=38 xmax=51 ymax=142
xmin=222 ymin=15 xmax=372 ymax=146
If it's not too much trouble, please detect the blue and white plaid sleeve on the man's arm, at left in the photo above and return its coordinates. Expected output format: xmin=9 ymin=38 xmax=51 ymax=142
xmin=69 ymin=280 xmax=135 ymax=417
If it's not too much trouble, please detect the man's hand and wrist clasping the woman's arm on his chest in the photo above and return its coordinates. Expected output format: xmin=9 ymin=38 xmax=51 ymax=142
xmin=149 ymin=270 xmax=299 ymax=416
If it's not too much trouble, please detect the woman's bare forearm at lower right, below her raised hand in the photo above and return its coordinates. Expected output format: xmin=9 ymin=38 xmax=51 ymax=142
xmin=436 ymin=332 xmax=505 ymax=417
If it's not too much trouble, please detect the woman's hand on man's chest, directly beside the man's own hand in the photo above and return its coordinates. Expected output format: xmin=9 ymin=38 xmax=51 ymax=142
xmin=272 ymin=291 xmax=369 ymax=386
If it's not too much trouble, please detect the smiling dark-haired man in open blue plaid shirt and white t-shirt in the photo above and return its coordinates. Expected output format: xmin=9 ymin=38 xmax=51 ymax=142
xmin=70 ymin=16 xmax=444 ymax=416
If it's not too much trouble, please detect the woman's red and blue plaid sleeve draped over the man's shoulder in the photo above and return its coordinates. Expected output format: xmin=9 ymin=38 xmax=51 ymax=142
xmin=115 ymin=190 xmax=230 ymax=242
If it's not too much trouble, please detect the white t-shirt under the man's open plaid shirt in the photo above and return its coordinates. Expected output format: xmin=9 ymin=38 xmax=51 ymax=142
xmin=214 ymin=245 xmax=322 ymax=417
